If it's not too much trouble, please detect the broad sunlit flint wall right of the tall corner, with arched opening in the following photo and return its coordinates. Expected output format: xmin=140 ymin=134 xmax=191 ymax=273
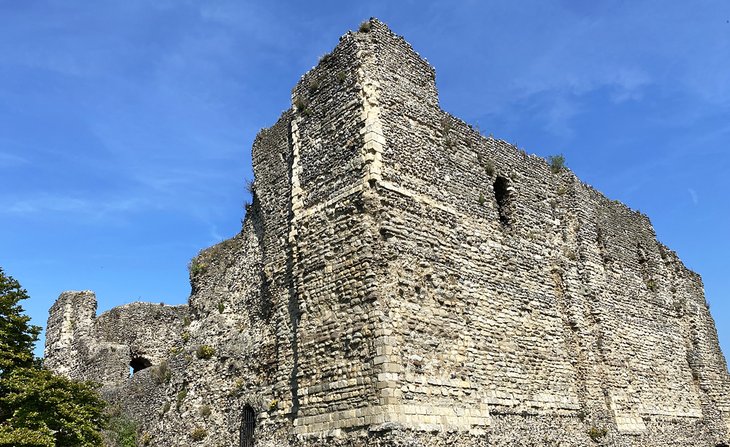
xmin=350 ymin=19 xmax=728 ymax=441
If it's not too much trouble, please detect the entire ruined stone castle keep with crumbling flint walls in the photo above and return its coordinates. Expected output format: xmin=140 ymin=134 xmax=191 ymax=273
xmin=46 ymin=20 xmax=730 ymax=447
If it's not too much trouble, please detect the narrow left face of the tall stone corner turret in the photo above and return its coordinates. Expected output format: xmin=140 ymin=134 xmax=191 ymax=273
xmin=289 ymin=30 xmax=382 ymax=433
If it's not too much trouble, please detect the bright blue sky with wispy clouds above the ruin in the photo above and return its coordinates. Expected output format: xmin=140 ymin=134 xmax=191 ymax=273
xmin=0 ymin=0 xmax=730 ymax=364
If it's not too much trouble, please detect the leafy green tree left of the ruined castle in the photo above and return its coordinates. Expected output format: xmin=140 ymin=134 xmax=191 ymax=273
xmin=0 ymin=269 xmax=105 ymax=447
